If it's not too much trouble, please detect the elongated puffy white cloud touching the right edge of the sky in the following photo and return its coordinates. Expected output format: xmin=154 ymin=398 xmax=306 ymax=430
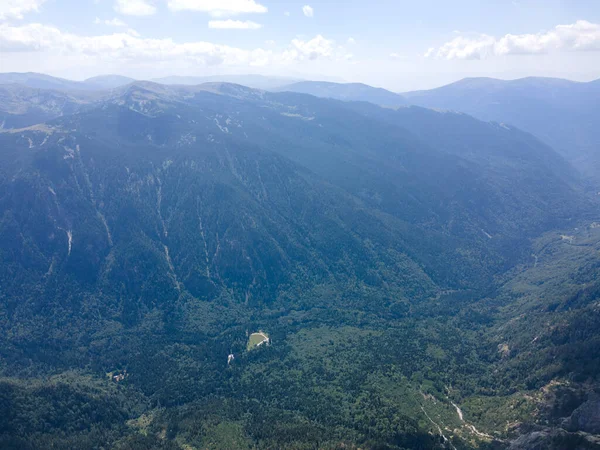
xmin=426 ymin=20 xmax=600 ymax=59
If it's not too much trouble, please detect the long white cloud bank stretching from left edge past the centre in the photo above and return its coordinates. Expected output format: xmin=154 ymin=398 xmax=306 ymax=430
xmin=0 ymin=23 xmax=342 ymax=66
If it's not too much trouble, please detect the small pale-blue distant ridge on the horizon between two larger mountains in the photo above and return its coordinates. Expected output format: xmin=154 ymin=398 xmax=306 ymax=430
xmin=278 ymin=81 xmax=407 ymax=108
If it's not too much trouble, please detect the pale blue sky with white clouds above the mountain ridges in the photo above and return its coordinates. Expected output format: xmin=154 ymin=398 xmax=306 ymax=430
xmin=0 ymin=0 xmax=600 ymax=92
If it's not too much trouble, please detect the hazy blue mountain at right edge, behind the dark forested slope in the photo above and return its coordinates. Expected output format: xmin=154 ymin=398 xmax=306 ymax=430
xmin=403 ymin=78 xmax=600 ymax=178
